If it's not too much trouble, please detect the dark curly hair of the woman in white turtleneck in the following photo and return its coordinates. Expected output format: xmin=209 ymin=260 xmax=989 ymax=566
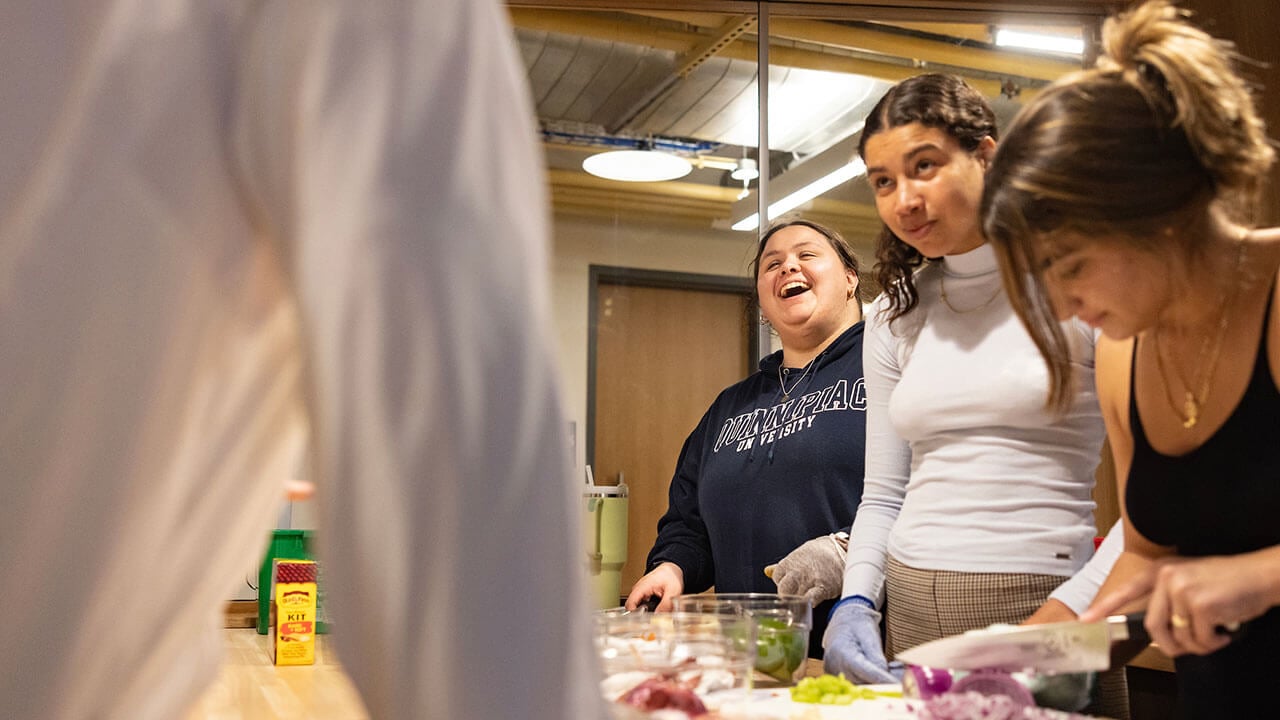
xmin=858 ymin=73 xmax=998 ymax=322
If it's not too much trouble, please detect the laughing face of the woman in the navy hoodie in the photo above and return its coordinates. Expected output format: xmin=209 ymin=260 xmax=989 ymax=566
xmin=755 ymin=225 xmax=860 ymax=348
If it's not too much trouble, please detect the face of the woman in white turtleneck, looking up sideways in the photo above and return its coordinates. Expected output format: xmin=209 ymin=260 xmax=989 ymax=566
xmin=865 ymin=123 xmax=996 ymax=258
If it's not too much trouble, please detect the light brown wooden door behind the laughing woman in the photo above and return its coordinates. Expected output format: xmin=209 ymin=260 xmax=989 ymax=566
xmin=588 ymin=271 xmax=756 ymax=596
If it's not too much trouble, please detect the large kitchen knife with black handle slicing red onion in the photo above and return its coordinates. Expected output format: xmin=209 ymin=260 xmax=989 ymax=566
xmin=897 ymin=612 xmax=1151 ymax=673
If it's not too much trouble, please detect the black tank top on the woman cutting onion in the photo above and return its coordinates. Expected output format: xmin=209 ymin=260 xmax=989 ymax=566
xmin=1125 ymin=281 xmax=1280 ymax=717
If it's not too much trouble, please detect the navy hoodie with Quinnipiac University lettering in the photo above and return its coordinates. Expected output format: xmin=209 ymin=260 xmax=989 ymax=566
xmin=646 ymin=317 xmax=867 ymax=639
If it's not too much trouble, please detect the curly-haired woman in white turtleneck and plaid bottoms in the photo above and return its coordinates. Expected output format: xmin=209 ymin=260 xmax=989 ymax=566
xmin=824 ymin=74 xmax=1121 ymax=717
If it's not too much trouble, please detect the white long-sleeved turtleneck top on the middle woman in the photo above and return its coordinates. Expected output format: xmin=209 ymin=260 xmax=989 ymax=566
xmin=844 ymin=245 xmax=1103 ymax=611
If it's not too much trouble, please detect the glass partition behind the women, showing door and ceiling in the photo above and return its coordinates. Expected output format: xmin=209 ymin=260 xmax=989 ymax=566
xmin=509 ymin=3 xmax=1101 ymax=589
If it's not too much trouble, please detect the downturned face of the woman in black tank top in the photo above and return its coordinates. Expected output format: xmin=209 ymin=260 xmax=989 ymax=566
xmin=1041 ymin=233 xmax=1172 ymax=340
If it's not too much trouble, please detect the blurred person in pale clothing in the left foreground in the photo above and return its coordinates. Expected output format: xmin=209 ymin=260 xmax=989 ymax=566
xmin=0 ymin=0 xmax=604 ymax=720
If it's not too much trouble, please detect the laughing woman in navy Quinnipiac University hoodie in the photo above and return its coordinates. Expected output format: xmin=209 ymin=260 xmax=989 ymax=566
xmin=626 ymin=219 xmax=867 ymax=656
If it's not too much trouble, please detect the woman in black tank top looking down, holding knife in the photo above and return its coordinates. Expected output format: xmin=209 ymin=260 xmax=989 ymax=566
xmin=967 ymin=0 xmax=1280 ymax=717
